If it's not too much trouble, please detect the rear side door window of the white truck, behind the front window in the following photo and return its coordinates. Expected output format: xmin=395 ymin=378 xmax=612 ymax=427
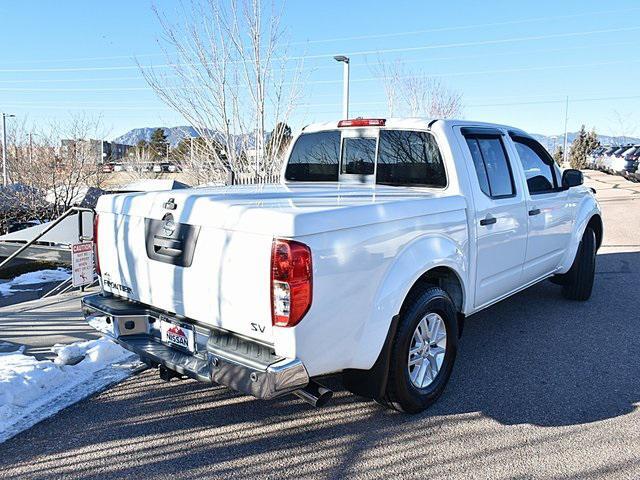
xmin=465 ymin=135 xmax=516 ymax=198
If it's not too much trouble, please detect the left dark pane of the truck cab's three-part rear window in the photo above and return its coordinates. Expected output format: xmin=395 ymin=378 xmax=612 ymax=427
xmin=284 ymin=130 xmax=340 ymax=182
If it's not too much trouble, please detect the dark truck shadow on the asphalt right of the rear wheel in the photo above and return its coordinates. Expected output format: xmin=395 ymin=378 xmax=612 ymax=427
xmin=436 ymin=252 xmax=640 ymax=426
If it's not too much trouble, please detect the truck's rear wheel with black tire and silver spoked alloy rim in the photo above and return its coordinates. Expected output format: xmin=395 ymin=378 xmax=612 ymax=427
xmin=381 ymin=287 xmax=458 ymax=413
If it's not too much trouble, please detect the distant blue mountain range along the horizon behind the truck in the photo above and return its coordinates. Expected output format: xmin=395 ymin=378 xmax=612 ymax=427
xmin=114 ymin=126 xmax=640 ymax=152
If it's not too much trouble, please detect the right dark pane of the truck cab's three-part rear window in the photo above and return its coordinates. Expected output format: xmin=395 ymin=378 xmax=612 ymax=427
xmin=376 ymin=130 xmax=447 ymax=187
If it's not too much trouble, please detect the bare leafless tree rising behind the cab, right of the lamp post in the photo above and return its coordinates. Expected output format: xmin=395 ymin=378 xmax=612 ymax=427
xmin=374 ymin=59 xmax=463 ymax=118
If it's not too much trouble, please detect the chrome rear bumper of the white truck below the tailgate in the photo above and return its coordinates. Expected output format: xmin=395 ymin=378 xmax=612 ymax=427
xmin=82 ymin=294 xmax=309 ymax=399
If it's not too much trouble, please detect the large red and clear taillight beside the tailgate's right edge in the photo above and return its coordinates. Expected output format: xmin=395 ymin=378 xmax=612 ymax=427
xmin=271 ymin=239 xmax=313 ymax=327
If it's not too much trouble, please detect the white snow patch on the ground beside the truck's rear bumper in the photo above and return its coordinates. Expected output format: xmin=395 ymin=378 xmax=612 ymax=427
xmin=0 ymin=337 xmax=142 ymax=443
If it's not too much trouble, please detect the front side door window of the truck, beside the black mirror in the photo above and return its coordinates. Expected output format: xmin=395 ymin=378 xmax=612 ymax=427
xmin=511 ymin=136 xmax=558 ymax=195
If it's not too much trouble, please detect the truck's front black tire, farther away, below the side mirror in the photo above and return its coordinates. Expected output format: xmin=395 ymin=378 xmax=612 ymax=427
xmin=562 ymin=227 xmax=596 ymax=302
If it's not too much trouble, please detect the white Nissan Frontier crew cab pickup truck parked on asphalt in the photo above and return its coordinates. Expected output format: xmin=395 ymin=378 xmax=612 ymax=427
xmin=82 ymin=118 xmax=603 ymax=412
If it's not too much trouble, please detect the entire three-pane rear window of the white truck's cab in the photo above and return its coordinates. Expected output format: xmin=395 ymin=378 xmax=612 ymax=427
xmin=285 ymin=128 xmax=447 ymax=188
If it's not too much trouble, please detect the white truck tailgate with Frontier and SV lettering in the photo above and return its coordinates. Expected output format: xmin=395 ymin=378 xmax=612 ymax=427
xmin=98 ymin=212 xmax=273 ymax=343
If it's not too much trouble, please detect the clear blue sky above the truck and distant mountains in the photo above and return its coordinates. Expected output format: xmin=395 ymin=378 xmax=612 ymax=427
xmin=0 ymin=0 xmax=640 ymax=138
